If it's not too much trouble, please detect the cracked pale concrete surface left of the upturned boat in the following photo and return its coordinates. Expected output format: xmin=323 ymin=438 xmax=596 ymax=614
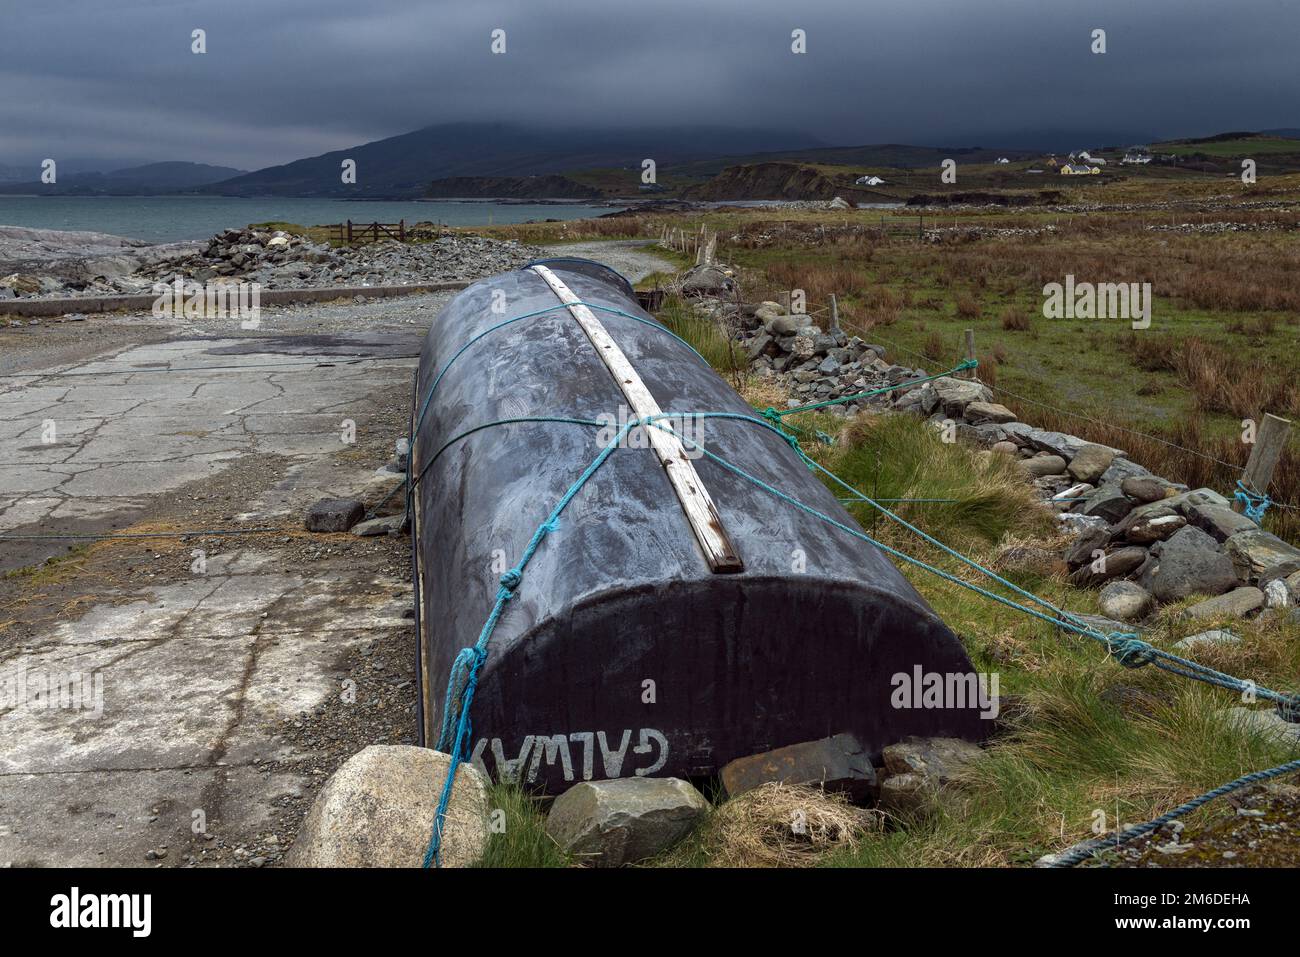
xmin=0 ymin=294 xmax=446 ymax=866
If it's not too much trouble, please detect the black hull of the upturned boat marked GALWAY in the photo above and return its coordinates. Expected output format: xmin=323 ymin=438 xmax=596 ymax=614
xmin=411 ymin=260 xmax=989 ymax=793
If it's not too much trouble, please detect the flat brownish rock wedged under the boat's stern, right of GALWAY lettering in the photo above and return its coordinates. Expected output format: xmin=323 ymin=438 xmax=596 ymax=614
xmin=720 ymin=735 xmax=880 ymax=801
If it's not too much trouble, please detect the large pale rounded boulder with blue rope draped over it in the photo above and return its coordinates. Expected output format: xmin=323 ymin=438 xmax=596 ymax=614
xmin=285 ymin=745 xmax=489 ymax=867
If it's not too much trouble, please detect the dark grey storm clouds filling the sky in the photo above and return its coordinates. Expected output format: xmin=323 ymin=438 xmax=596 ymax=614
xmin=0 ymin=0 xmax=1300 ymax=168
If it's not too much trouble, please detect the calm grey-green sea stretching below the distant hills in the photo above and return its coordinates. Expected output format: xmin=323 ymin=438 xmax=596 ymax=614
xmin=0 ymin=196 xmax=610 ymax=243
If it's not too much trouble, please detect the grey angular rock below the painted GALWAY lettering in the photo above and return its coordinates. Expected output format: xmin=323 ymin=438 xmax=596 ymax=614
xmin=546 ymin=778 xmax=709 ymax=867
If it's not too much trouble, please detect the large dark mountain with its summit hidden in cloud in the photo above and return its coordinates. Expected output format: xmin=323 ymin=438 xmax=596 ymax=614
xmin=202 ymin=124 xmax=823 ymax=199
